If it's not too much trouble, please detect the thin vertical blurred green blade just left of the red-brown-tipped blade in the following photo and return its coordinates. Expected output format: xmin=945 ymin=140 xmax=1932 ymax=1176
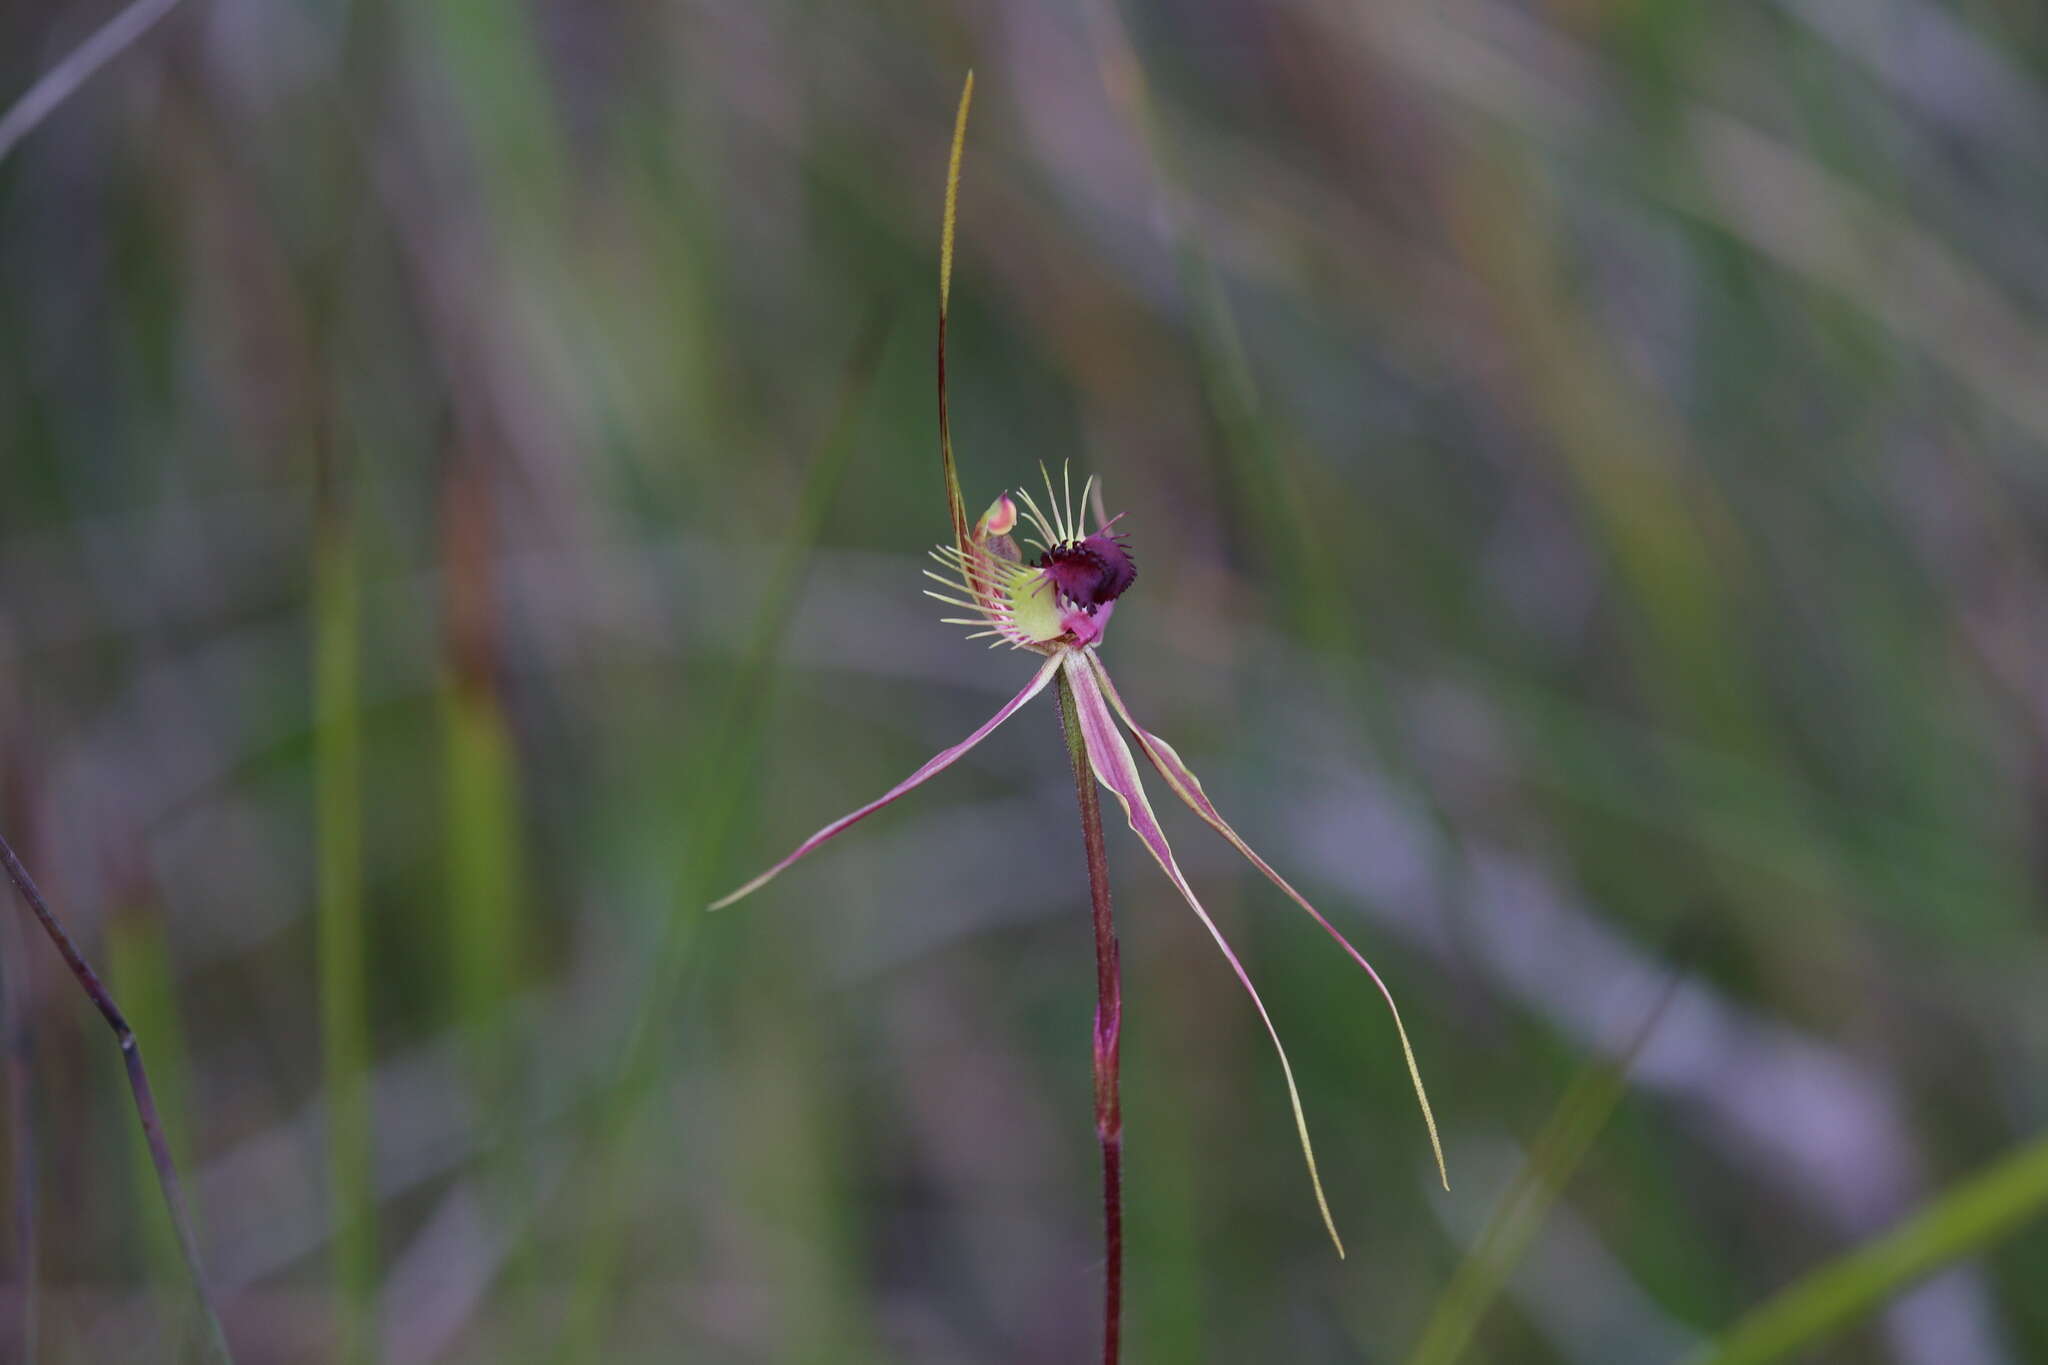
xmin=313 ymin=505 xmax=377 ymax=1363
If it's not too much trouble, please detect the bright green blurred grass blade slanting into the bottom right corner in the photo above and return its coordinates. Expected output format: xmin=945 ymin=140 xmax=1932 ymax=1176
xmin=1692 ymin=1136 xmax=2048 ymax=1365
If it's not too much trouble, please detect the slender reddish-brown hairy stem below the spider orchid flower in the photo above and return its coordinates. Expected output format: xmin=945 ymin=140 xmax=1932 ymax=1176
xmin=1057 ymin=669 xmax=1124 ymax=1365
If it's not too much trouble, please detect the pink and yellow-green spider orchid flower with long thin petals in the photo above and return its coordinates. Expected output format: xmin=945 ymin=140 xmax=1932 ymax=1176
xmin=711 ymin=78 xmax=1448 ymax=1257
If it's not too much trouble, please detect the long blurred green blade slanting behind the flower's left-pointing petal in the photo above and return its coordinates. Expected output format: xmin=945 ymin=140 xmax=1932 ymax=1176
xmin=559 ymin=309 xmax=889 ymax=1361
